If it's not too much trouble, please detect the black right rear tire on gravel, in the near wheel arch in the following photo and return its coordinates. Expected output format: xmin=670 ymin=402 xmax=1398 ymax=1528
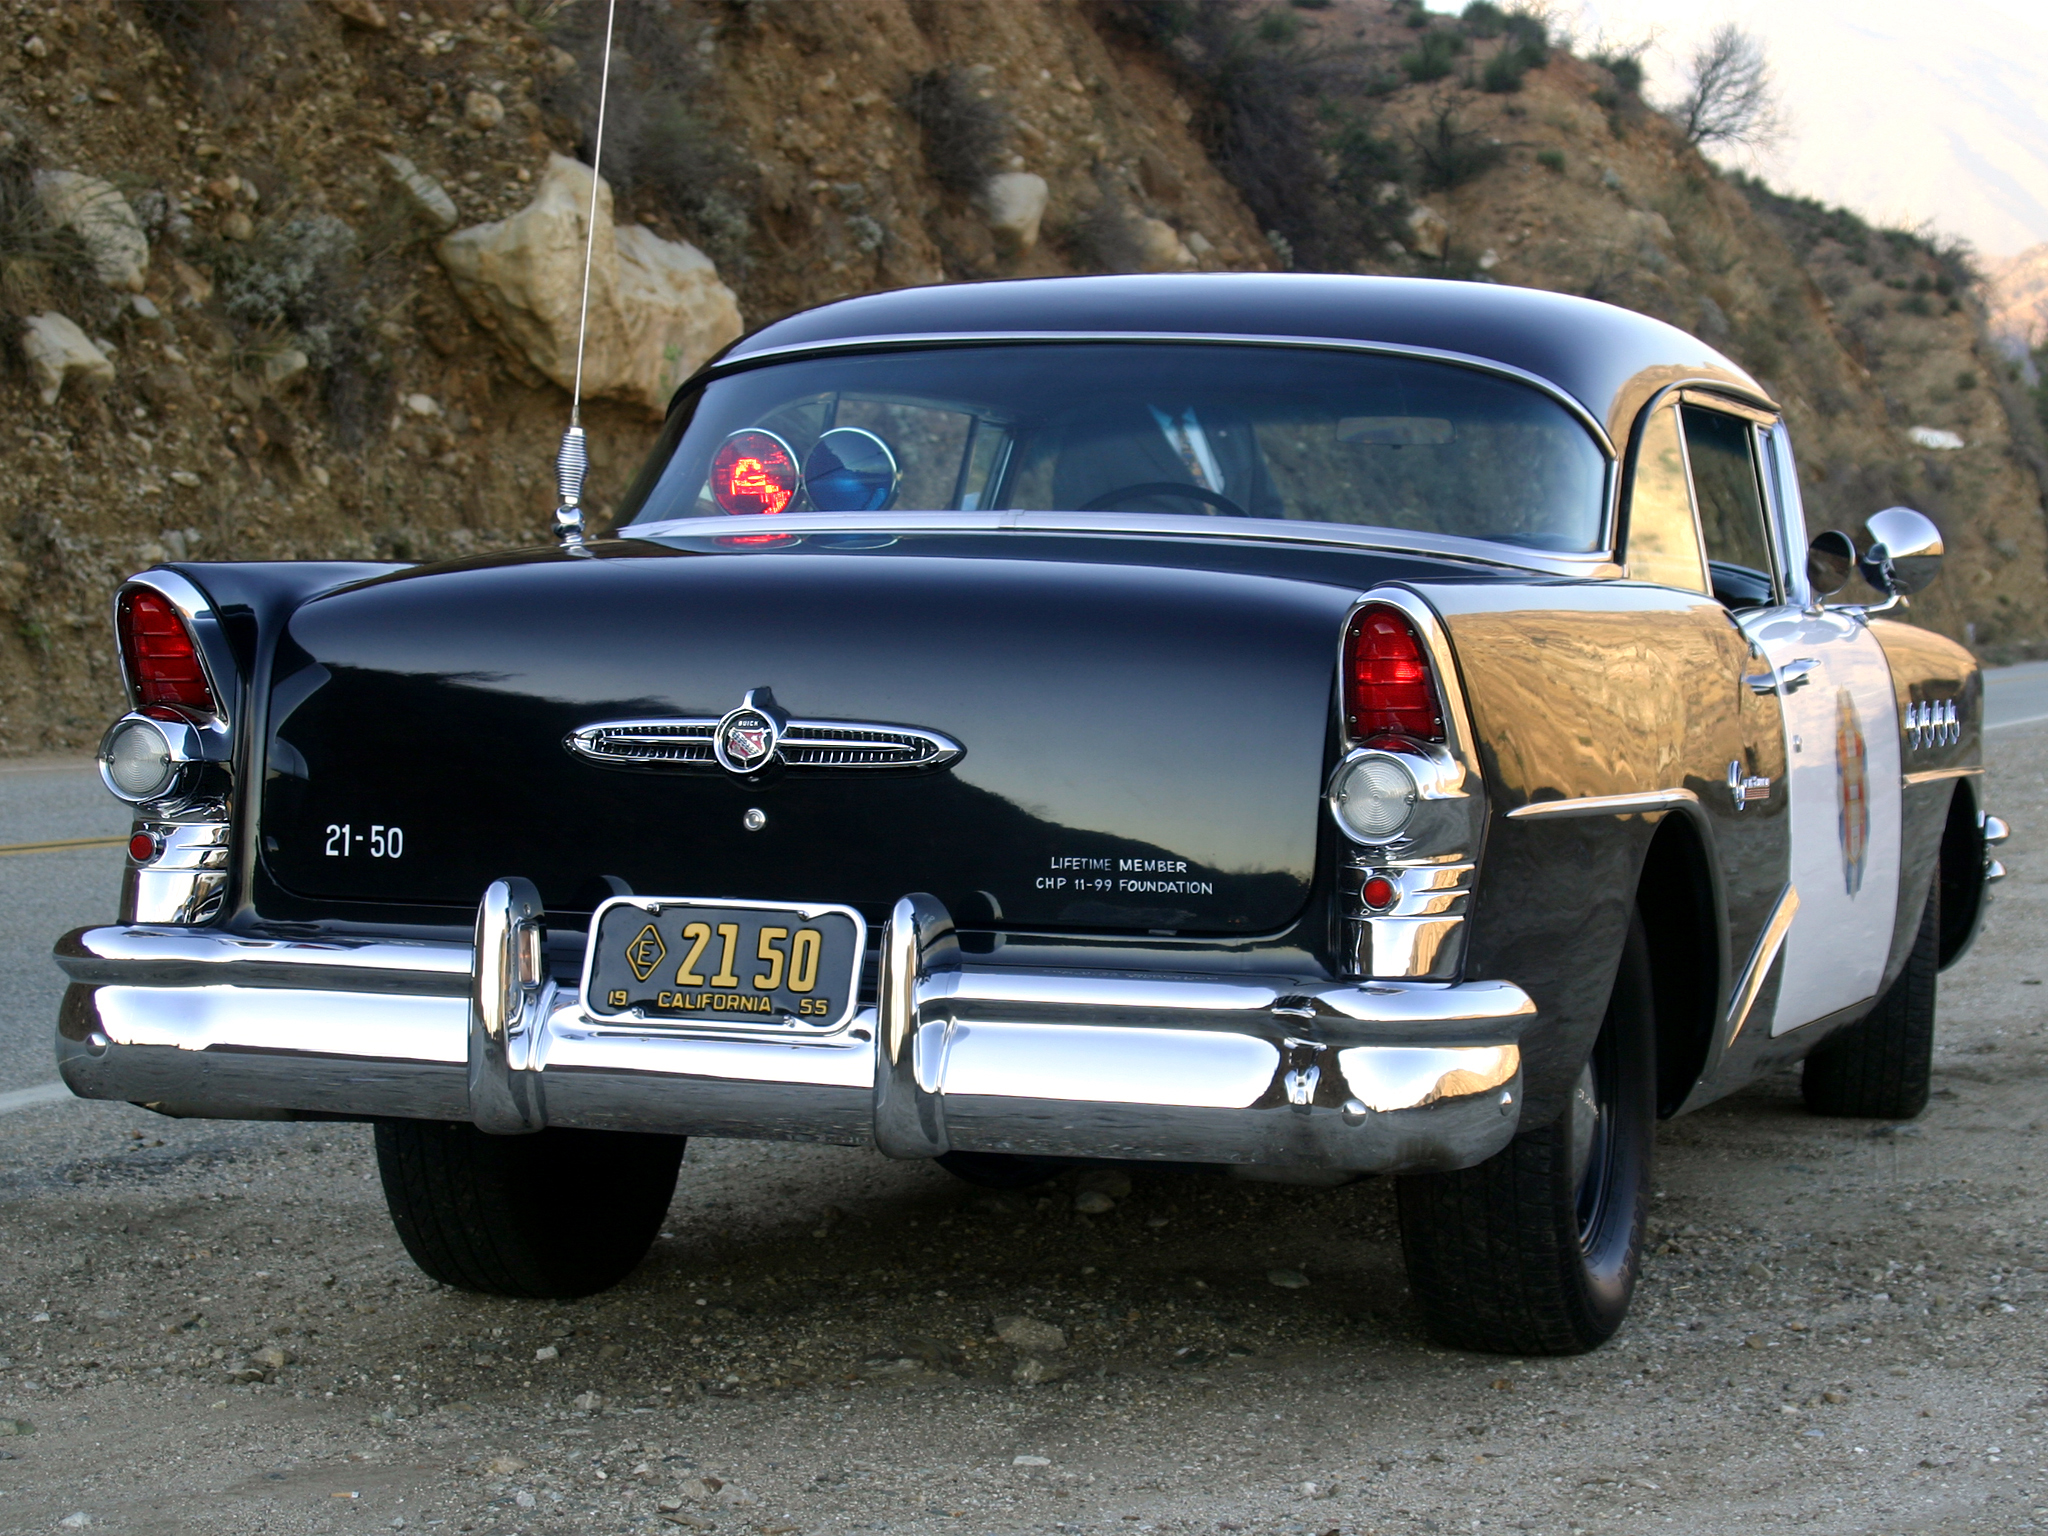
xmin=1395 ymin=915 xmax=1657 ymax=1356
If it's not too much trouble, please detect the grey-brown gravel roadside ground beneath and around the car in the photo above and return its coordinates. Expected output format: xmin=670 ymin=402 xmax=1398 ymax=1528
xmin=0 ymin=725 xmax=2048 ymax=1536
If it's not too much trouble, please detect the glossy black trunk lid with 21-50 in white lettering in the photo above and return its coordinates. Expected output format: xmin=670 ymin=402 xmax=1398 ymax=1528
xmin=262 ymin=535 xmax=1444 ymax=934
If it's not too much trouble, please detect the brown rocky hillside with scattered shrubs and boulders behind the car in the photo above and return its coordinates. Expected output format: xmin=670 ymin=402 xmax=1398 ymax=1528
xmin=0 ymin=0 xmax=2048 ymax=752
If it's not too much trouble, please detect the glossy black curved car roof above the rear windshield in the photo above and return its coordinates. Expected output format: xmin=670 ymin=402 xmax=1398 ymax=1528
xmin=721 ymin=272 xmax=1776 ymax=442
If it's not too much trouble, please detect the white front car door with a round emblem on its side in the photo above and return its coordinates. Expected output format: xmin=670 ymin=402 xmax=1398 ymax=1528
xmin=1736 ymin=424 xmax=1901 ymax=1036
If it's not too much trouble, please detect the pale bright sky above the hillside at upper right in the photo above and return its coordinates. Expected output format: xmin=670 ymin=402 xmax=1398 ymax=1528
xmin=1430 ymin=0 xmax=2048 ymax=260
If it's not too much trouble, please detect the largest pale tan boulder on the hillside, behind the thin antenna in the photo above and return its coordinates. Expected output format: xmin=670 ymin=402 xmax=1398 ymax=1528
xmin=440 ymin=156 xmax=741 ymax=416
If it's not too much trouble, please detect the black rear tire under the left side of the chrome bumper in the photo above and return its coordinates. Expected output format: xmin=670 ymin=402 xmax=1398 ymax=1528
xmin=377 ymin=1120 xmax=684 ymax=1298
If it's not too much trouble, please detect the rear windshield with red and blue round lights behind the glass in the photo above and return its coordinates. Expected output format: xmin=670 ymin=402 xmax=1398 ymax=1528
xmin=621 ymin=342 xmax=1606 ymax=551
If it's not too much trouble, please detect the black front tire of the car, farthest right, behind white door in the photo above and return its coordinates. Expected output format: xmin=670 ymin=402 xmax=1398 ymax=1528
xmin=1798 ymin=879 xmax=1942 ymax=1120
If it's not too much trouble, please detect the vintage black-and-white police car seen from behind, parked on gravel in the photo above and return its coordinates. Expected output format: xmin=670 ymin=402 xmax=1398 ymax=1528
xmin=59 ymin=279 xmax=1997 ymax=1352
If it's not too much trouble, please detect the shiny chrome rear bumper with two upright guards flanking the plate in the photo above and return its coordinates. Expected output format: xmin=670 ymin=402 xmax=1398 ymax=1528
xmin=57 ymin=881 xmax=1534 ymax=1171
